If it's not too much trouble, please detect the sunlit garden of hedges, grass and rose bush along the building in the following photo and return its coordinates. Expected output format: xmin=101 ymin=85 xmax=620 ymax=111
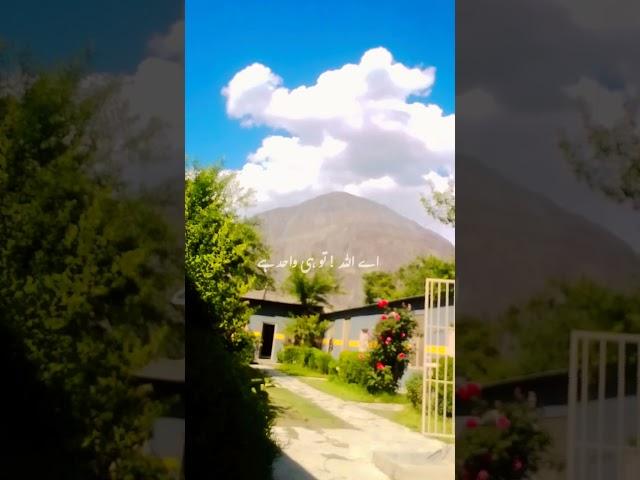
xmin=278 ymin=299 xmax=453 ymax=433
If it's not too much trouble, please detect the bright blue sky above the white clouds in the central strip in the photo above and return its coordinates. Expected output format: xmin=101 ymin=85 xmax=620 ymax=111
xmin=185 ymin=0 xmax=455 ymax=168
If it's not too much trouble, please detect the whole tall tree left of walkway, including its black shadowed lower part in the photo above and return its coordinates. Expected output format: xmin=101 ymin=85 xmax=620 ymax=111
xmin=185 ymin=166 xmax=277 ymax=478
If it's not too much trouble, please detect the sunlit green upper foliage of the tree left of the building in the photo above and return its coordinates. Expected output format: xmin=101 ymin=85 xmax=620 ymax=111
xmin=184 ymin=166 xmax=267 ymax=349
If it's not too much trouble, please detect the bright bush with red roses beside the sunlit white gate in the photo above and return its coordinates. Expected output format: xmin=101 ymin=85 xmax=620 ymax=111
xmin=367 ymin=299 xmax=416 ymax=393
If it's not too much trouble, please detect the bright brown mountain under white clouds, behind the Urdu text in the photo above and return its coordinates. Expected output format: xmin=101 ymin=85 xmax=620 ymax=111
xmin=250 ymin=192 xmax=454 ymax=309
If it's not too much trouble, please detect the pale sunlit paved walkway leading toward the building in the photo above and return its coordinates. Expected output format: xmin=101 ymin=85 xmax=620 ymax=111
xmin=257 ymin=365 xmax=450 ymax=480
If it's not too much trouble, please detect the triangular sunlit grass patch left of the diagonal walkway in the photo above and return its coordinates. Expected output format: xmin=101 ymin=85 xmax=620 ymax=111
xmin=266 ymin=386 xmax=353 ymax=429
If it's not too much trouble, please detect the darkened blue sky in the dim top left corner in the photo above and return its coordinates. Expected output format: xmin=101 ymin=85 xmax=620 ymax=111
xmin=0 ymin=0 xmax=183 ymax=73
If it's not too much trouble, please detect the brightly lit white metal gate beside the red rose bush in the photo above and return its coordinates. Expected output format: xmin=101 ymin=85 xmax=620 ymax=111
xmin=422 ymin=278 xmax=456 ymax=438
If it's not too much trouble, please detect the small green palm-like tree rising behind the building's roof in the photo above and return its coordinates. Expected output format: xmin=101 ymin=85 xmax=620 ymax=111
xmin=283 ymin=267 xmax=341 ymax=308
